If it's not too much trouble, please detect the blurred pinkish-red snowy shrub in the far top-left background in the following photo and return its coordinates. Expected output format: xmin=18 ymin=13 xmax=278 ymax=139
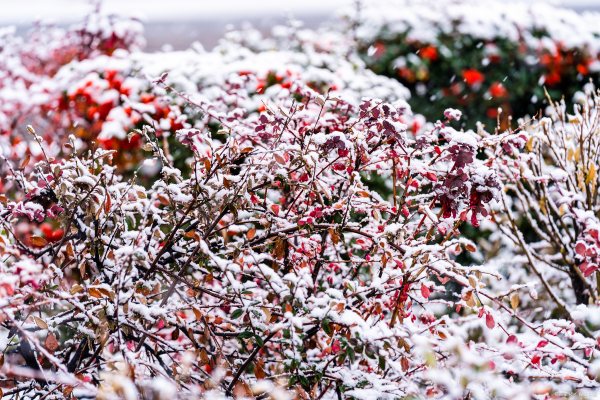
xmin=0 ymin=13 xmax=143 ymax=135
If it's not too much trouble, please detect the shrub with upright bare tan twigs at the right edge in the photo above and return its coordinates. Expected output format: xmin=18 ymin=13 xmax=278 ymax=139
xmin=490 ymin=89 xmax=600 ymax=312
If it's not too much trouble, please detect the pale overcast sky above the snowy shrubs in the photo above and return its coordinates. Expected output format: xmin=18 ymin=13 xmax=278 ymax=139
xmin=0 ymin=0 xmax=600 ymax=51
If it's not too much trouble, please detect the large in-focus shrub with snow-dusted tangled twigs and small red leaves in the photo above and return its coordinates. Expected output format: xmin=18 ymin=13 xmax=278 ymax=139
xmin=0 ymin=70 xmax=548 ymax=398
